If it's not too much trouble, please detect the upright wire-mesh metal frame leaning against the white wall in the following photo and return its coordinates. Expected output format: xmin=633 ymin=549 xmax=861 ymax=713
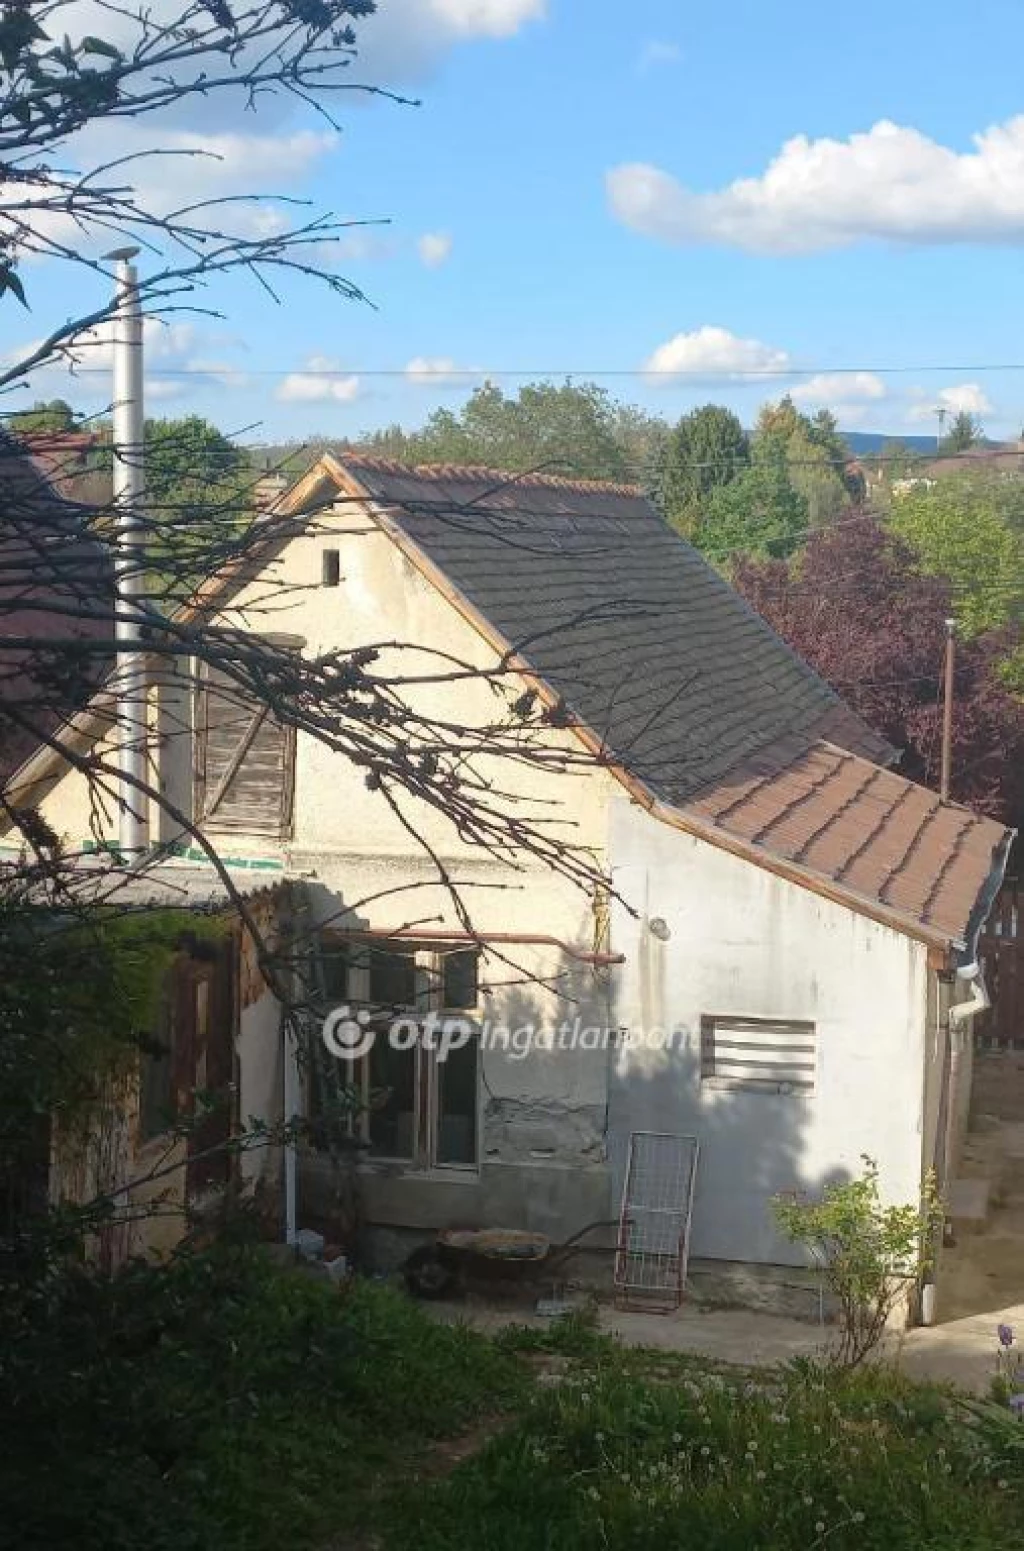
xmin=614 ymin=1131 xmax=700 ymax=1314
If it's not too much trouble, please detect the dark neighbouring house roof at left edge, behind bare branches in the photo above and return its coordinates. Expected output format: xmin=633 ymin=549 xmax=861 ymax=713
xmin=0 ymin=436 xmax=113 ymax=782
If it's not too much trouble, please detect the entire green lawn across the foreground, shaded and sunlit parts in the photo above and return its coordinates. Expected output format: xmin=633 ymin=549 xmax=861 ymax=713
xmin=0 ymin=1255 xmax=1024 ymax=1551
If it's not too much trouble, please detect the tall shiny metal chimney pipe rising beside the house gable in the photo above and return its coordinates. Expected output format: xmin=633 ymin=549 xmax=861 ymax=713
xmin=106 ymin=248 xmax=149 ymax=865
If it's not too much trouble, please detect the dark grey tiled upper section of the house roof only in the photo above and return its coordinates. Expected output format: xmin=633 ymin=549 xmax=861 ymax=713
xmin=344 ymin=456 xmax=892 ymax=803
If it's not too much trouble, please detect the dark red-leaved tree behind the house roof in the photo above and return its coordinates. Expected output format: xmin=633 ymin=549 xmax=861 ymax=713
xmin=734 ymin=516 xmax=1024 ymax=827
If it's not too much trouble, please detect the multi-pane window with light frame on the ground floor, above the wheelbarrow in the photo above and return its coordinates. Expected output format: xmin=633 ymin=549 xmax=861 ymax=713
xmin=316 ymin=940 xmax=479 ymax=1168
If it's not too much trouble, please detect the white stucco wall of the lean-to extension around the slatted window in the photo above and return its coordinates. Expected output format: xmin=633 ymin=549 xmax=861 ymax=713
xmin=610 ymin=797 xmax=928 ymax=1264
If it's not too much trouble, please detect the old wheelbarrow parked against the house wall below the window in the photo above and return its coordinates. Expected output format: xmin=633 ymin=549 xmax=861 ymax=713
xmin=402 ymin=1218 xmax=618 ymax=1298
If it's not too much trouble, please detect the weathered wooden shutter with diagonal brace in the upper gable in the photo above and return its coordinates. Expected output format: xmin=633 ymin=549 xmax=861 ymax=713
xmin=195 ymin=662 xmax=295 ymax=838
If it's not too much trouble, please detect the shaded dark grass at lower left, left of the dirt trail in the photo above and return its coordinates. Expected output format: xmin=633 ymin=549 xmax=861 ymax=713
xmin=0 ymin=1253 xmax=528 ymax=1551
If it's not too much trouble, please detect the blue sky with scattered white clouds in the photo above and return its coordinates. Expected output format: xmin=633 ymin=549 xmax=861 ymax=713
xmin=12 ymin=0 xmax=1024 ymax=439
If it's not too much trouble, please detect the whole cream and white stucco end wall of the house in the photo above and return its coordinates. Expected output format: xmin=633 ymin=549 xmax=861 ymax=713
xmin=19 ymin=493 xmax=928 ymax=1264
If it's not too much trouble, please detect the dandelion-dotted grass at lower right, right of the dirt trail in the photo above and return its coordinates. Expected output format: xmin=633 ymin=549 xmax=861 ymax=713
xmin=382 ymin=1328 xmax=1024 ymax=1551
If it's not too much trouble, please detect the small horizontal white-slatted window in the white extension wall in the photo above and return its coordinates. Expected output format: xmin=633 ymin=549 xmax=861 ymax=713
xmin=700 ymin=1016 xmax=818 ymax=1093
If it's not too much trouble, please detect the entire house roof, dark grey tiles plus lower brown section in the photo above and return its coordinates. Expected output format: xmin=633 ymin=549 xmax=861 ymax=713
xmin=343 ymin=456 xmax=1007 ymax=946
